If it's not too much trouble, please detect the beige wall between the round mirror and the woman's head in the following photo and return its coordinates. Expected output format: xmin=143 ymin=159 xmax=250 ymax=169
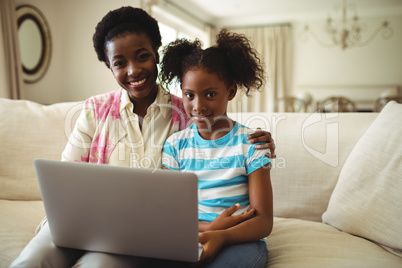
xmin=15 ymin=0 xmax=139 ymax=104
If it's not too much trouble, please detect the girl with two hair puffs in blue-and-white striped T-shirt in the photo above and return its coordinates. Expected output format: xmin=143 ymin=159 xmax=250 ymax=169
xmin=161 ymin=30 xmax=273 ymax=267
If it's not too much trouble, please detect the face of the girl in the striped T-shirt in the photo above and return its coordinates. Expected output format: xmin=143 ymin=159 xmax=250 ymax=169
xmin=182 ymin=68 xmax=236 ymax=140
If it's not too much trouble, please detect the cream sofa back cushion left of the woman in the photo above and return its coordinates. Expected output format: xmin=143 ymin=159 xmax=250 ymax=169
xmin=0 ymin=99 xmax=82 ymax=200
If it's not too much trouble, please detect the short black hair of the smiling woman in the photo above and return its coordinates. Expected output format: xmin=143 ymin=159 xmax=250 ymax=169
xmin=92 ymin=6 xmax=162 ymax=68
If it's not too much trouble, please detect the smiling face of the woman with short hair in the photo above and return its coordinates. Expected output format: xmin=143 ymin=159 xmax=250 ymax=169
xmin=106 ymin=33 xmax=159 ymax=101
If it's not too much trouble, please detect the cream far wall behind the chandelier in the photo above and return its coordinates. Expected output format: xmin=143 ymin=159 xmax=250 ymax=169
xmin=292 ymin=15 xmax=402 ymax=110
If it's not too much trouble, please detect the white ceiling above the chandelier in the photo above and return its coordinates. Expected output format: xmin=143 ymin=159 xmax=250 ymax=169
xmin=165 ymin=0 xmax=402 ymax=26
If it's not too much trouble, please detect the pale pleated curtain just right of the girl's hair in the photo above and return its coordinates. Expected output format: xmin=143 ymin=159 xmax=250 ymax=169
xmin=228 ymin=25 xmax=292 ymax=112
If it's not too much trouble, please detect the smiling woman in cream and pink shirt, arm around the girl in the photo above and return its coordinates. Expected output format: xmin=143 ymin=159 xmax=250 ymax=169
xmin=11 ymin=6 xmax=274 ymax=267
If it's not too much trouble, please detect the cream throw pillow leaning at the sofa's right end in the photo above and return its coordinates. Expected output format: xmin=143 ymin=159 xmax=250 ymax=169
xmin=323 ymin=102 xmax=402 ymax=256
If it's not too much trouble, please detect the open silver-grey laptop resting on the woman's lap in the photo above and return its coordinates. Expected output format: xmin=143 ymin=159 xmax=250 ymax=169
xmin=34 ymin=159 xmax=202 ymax=262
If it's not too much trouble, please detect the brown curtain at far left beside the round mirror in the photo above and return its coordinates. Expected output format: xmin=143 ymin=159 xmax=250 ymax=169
xmin=0 ymin=0 xmax=24 ymax=99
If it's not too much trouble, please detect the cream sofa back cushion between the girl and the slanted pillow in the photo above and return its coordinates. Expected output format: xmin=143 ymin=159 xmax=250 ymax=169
xmin=229 ymin=113 xmax=378 ymax=222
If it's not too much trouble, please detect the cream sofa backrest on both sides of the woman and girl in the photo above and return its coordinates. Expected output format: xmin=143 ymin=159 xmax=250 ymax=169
xmin=0 ymin=99 xmax=380 ymax=221
